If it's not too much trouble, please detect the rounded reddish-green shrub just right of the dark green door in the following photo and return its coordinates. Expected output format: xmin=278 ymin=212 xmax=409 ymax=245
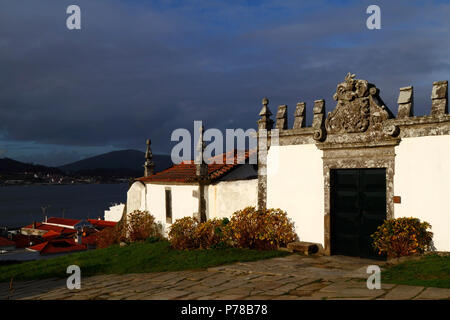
xmin=372 ymin=218 xmax=433 ymax=257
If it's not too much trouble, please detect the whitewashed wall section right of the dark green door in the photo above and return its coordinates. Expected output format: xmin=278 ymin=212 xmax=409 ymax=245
xmin=394 ymin=135 xmax=450 ymax=251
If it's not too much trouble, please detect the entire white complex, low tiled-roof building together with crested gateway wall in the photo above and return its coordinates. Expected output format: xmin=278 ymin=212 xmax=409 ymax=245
xmin=127 ymin=74 xmax=450 ymax=257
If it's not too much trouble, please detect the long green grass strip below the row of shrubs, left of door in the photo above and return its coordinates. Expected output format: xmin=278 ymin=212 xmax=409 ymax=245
xmin=0 ymin=241 xmax=289 ymax=282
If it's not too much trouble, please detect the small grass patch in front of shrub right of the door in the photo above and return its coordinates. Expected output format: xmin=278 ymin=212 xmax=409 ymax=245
xmin=381 ymin=255 xmax=450 ymax=288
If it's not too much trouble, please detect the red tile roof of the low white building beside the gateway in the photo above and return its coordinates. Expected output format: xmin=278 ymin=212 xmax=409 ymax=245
xmin=136 ymin=150 xmax=254 ymax=182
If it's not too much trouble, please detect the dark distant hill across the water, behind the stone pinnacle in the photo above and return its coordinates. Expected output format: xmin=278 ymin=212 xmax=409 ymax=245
xmin=59 ymin=150 xmax=172 ymax=177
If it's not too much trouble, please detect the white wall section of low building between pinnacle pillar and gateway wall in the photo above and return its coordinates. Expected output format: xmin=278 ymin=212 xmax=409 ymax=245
xmin=206 ymin=179 xmax=258 ymax=219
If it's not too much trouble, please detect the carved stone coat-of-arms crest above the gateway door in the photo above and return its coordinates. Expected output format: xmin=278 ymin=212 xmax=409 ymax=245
xmin=325 ymin=73 xmax=392 ymax=133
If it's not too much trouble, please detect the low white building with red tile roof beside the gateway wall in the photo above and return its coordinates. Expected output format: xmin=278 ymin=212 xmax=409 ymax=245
xmin=126 ymin=152 xmax=258 ymax=231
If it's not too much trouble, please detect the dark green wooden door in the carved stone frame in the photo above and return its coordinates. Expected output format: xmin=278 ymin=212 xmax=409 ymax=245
xmin=330 ymin=168 xmax=386 ymax=259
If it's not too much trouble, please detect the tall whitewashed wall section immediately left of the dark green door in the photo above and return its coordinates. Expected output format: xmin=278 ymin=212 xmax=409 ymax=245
xmin=267 ymin=144 xmax=324 ymax=245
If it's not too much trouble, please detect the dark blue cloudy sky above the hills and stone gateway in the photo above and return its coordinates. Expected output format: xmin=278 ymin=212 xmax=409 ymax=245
xmin=0 ymin=0 xmax=450 ymax=166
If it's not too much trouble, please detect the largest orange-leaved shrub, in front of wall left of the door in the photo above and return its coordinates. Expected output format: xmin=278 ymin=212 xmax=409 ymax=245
xmin=227 ymin=207 xmax=298 ymax=250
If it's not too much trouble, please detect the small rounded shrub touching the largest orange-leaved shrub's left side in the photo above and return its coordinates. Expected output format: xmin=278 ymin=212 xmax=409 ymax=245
xmin=194 ymin=218 xmax=228 ymax=249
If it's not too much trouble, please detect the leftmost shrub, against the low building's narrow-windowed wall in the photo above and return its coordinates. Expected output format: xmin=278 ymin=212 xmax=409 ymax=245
xmin=126 ymin=210 xmax=163 ymax=242
